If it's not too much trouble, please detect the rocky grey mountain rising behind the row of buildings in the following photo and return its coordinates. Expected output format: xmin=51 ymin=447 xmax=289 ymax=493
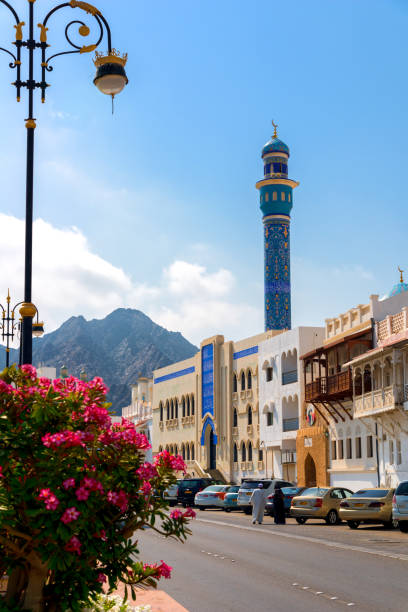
xmin=0 ymin=308 xmax=198 ymax=413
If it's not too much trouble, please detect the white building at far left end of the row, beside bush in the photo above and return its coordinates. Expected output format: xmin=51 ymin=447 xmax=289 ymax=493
xmin=122 ymin=376 xmax=153 ymax=461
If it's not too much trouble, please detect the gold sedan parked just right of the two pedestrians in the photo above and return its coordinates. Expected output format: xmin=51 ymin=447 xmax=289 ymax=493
xmin=290 ymin=487 xmax=353 ymax=525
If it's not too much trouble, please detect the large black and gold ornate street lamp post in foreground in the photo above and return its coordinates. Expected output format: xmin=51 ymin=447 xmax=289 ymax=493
xmin=0 ymin=0 xmax=128 ymax=364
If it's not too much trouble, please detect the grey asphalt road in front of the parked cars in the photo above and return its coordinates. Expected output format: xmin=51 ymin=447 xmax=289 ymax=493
xmin=139 ymin=511 xmax=408 ymax=612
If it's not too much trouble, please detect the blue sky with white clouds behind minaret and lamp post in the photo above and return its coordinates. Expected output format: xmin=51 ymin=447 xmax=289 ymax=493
xmin=0 ymin=0 xmax=408 ymax=343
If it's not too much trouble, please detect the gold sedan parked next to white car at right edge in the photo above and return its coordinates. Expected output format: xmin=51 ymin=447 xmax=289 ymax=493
xmin=339 ymin=487 xmax=395 ymax=529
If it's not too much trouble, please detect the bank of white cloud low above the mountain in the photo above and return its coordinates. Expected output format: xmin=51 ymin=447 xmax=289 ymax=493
xmin=0 ymin=213 xmax=262 ymax=343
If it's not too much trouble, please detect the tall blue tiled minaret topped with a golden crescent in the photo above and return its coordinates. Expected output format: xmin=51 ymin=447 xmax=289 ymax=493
xmin=256 ymin=121 xmax=299 ymax=331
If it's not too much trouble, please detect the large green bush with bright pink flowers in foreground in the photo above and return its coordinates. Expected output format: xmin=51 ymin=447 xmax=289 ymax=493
xmin=0 ymin=366 xmax=194 ymax=612
